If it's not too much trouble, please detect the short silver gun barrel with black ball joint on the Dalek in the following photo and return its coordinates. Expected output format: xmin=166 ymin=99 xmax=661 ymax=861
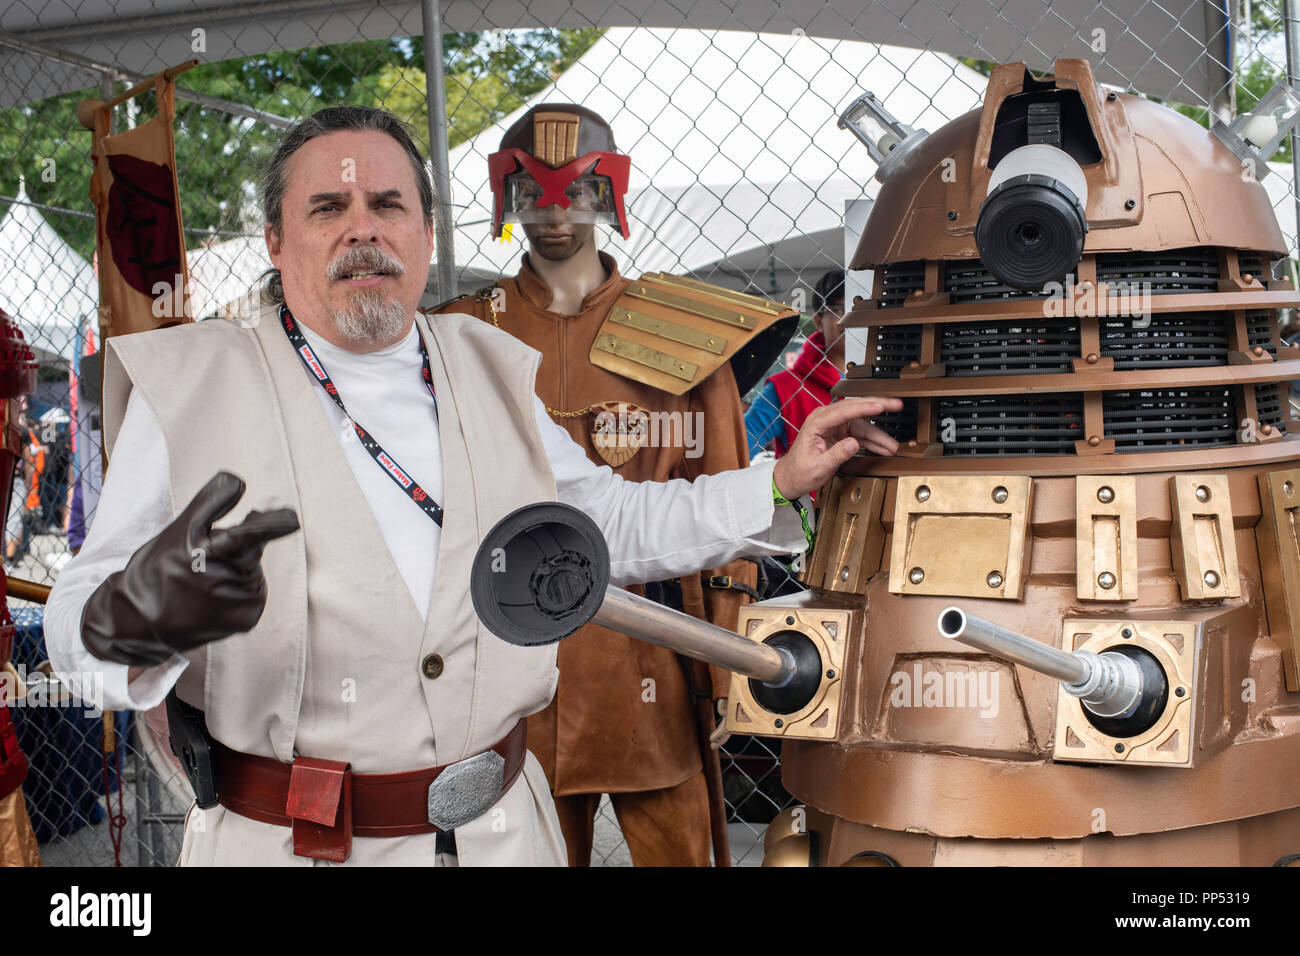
xmin=939 ymin=607 xmax=1169 ymax=737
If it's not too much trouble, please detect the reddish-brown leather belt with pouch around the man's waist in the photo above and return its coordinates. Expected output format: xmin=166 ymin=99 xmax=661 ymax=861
xmin=212 ymin=721 xmax=525 ymax=860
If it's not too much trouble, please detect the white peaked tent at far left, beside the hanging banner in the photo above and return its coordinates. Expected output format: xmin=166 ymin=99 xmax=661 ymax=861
xmin=0 ymin=185 xmax=99 ymax=363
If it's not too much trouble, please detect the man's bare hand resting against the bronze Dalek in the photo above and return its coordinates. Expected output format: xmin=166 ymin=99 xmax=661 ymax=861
xmin=772 ymin=398 xmax=902 ymax=501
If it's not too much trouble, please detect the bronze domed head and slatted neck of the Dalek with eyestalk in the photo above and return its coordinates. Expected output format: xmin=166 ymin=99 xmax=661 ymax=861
xmin=840 ymin=60 xmax=1300 ymax=463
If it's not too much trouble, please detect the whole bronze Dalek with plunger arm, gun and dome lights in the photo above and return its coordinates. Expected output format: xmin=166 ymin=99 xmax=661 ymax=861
xmin=472 ymin=60 xmax=1300 ymax=866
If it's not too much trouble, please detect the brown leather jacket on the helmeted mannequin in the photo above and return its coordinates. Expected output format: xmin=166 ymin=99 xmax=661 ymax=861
xmin=436 ymin=252 xmax=757 ymax=796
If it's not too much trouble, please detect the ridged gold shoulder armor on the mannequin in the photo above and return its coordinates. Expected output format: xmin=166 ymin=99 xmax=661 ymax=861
xmin=590 ymin=272 xmax=798 ymax=395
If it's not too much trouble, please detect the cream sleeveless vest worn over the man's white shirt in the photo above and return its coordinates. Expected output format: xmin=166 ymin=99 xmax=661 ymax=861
xmin=104 ymin=308 xmax=556 ymax=773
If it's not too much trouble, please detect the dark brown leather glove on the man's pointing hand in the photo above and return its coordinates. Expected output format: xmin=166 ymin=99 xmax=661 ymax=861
xmin=81 ymin=471 xmax=298 ymax=666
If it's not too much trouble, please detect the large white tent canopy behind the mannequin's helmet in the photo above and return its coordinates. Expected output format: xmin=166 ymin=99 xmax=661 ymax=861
xmin=441 ymin=29 xmax=987 ymax=294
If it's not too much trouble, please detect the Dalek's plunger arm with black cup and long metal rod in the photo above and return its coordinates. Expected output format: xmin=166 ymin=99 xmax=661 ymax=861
xmin=469 ymin=503 xmax=822 ymax=711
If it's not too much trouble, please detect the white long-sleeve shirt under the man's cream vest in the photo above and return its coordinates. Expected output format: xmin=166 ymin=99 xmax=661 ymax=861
xmin=46 ymin=317 xmax=806 ymax=709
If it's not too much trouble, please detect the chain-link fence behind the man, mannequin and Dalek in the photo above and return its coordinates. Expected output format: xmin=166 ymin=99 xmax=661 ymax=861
xmin=0 ymin=0 xmax=1297 ymax=865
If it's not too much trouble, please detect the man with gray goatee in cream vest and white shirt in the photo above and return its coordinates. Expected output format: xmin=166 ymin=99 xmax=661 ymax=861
xmin=46 ymin=107 xmax=894 ymax=865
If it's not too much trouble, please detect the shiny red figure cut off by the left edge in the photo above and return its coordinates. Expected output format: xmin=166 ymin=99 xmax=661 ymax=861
xmin=0 ymin=310 xmax=36 ymax=806
